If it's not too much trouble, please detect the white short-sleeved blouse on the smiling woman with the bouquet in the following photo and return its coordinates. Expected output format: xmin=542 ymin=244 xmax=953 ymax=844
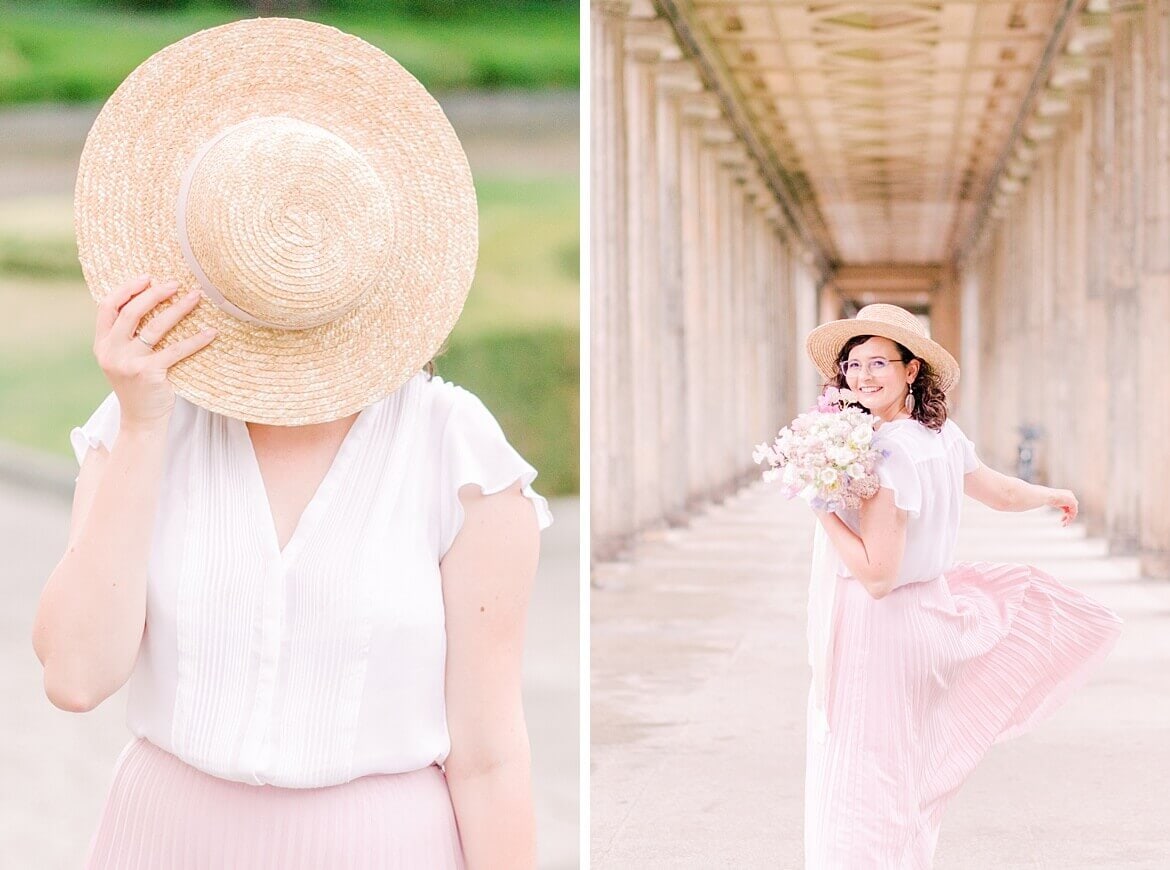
xmin=840 ymin=420 xmax=979 ymax=588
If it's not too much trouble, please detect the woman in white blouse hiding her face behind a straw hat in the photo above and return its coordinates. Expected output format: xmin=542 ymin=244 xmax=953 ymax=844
xmin=33 ymin=19 xmax=551 ymax=870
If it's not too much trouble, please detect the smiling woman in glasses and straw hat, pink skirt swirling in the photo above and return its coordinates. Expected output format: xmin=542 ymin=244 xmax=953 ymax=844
xmin=805 ymin=304 xmax=1121 ymax=870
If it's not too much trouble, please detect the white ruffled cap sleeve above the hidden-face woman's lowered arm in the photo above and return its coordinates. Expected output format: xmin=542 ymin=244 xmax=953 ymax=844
xmin=439 ymin=387 xmax=552 ymax=558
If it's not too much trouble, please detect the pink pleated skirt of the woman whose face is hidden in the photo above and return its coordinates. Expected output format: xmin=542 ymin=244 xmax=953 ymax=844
xmin=85 ymin=739 xmax=463 ymax=870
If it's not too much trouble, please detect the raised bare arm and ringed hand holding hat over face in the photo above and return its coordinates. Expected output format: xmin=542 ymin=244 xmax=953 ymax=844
xmin=33 ymin=276 xmax=214 ymax=712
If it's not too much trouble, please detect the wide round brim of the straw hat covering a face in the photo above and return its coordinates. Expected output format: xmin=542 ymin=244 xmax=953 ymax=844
xmin=74 ymin=18 xmax=479 ymax=426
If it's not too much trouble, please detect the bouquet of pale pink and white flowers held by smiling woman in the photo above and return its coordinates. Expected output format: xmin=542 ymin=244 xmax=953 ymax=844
xmin=752 ymin=387 xmax=882 ymax=511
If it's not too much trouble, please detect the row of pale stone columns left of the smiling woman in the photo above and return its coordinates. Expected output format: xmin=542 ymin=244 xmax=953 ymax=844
xmin=590 ymin=0 xmax=817 ymax=559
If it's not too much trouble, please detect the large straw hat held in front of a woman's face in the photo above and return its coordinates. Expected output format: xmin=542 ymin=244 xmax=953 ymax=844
xmin=74 ymin=18 xmax=479 ymax=426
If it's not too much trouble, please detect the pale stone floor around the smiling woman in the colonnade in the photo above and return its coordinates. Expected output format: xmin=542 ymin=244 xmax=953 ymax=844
xmin=591 ymin=483 xmax=1170 ymax=870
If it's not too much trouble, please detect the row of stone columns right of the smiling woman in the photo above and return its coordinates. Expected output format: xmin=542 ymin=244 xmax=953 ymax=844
xmin=959 ymin=0 xmax=1170 ymax=578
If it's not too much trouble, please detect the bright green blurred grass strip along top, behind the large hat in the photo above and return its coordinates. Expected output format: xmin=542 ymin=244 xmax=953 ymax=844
xmin=0 ymin=0 xmax=579 ymax=104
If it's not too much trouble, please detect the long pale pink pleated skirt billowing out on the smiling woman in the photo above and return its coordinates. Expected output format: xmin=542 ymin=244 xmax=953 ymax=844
xmin=805 ymin=562 xmax=1121 ymax=870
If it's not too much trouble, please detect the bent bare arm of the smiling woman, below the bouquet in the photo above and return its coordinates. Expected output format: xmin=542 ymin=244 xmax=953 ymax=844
xmin=817 ymin=486 xmax=907 ymax=599
